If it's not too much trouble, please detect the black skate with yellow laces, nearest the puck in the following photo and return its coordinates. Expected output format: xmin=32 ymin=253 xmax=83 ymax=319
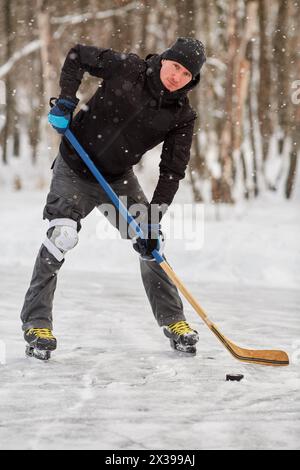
xmin=163 ymin=321 xmax=199 ymax=356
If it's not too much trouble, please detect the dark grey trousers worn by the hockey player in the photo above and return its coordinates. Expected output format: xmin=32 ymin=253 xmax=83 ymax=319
xmin=21 ymin=154 xmax=185 ymax=330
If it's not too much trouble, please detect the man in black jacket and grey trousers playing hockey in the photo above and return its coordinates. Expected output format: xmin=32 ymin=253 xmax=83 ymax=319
xmin=21 ymin=38 xmax=206 ymax=358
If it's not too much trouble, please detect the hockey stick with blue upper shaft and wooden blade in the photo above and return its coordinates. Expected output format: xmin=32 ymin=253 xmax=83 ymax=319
xmin=64 ymin=129 xmax=289 ymax=366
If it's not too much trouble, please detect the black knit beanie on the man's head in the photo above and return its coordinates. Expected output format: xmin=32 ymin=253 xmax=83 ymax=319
xmin=161 ymin=38 xmax=206 ymax=77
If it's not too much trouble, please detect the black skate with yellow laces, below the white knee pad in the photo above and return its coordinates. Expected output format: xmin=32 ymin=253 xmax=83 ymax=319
xmin=24 ymin=328 xmax=57 ymax=361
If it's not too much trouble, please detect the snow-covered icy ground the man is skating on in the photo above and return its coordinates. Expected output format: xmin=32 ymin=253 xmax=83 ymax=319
xmin=0 ymin=172 xmax=300 ymax=450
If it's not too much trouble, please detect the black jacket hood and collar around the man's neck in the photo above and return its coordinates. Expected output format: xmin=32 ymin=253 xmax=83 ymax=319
xmin=145 ymin=54 xmax=201 ymax=108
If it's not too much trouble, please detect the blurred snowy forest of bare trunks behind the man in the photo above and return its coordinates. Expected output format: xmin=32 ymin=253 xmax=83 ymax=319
xmin=0 ymin=0 xmax=300 ymax=203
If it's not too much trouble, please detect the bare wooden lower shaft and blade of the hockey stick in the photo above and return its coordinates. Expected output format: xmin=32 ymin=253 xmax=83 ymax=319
xmin=160 ymin=261 xmax=289 ymax=366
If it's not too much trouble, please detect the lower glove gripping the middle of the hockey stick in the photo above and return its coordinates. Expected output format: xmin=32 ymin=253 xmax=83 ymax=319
xmin=132 ymin=223 xmax=165 ymax=261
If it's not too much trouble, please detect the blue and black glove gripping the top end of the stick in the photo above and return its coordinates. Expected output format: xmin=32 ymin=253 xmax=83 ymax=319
xmin=48 ymin=98 xmax=78 ymax=134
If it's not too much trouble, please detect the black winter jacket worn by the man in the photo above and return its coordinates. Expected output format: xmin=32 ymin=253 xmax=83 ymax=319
xmin=60 ymin=44 xmax=200 ymax=209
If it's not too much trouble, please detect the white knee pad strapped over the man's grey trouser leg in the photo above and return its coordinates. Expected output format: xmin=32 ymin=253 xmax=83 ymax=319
xmin=43 ymin=219 xmax=78 ymax=262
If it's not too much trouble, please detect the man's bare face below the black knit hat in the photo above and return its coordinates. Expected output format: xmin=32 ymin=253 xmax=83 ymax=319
xmin=160 ymin=59 xmax=193 ymax=91
